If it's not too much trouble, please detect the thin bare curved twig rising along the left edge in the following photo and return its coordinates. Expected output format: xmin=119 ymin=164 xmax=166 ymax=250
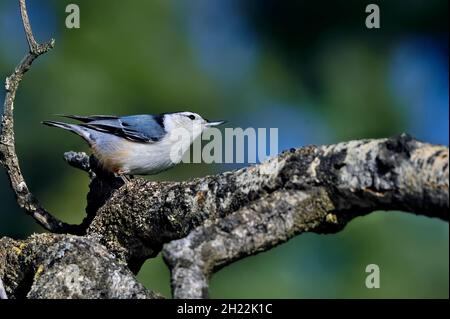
xmin=0 ymin=0 xmax=79 ymax=233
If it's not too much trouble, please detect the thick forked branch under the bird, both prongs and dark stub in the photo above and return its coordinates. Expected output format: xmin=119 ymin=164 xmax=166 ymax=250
xmin=0 ymin=135 xmax=449 ymax=298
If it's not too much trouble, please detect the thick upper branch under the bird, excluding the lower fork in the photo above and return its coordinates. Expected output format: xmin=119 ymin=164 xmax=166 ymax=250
xmin=79 ymin=135 xmax=448 ymax=276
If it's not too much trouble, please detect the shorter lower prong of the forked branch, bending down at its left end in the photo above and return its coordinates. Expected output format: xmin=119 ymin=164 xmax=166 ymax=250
xmin=164 ymin=189 xmax=336 ymax=298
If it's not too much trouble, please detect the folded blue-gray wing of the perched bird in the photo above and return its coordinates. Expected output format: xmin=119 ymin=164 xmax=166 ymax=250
xmin=77 ymin=115 xmax=166 ymax=143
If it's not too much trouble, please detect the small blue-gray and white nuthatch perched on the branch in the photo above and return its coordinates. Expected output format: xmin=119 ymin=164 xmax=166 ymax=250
xmin=42 ymin=112 xmax=224 ymax=176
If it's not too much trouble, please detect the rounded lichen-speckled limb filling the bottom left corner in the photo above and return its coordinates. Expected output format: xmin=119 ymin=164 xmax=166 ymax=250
xmin=0 ymin=234 xmax=161 ymax=299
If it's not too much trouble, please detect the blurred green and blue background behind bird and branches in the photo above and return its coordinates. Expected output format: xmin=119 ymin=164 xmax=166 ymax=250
xmin=0 ymin=0 xmax=449 ymax=298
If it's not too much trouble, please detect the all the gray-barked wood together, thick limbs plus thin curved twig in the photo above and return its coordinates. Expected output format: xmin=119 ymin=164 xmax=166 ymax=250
xmin=0 ymin=0 xmax=449 ymax=298
